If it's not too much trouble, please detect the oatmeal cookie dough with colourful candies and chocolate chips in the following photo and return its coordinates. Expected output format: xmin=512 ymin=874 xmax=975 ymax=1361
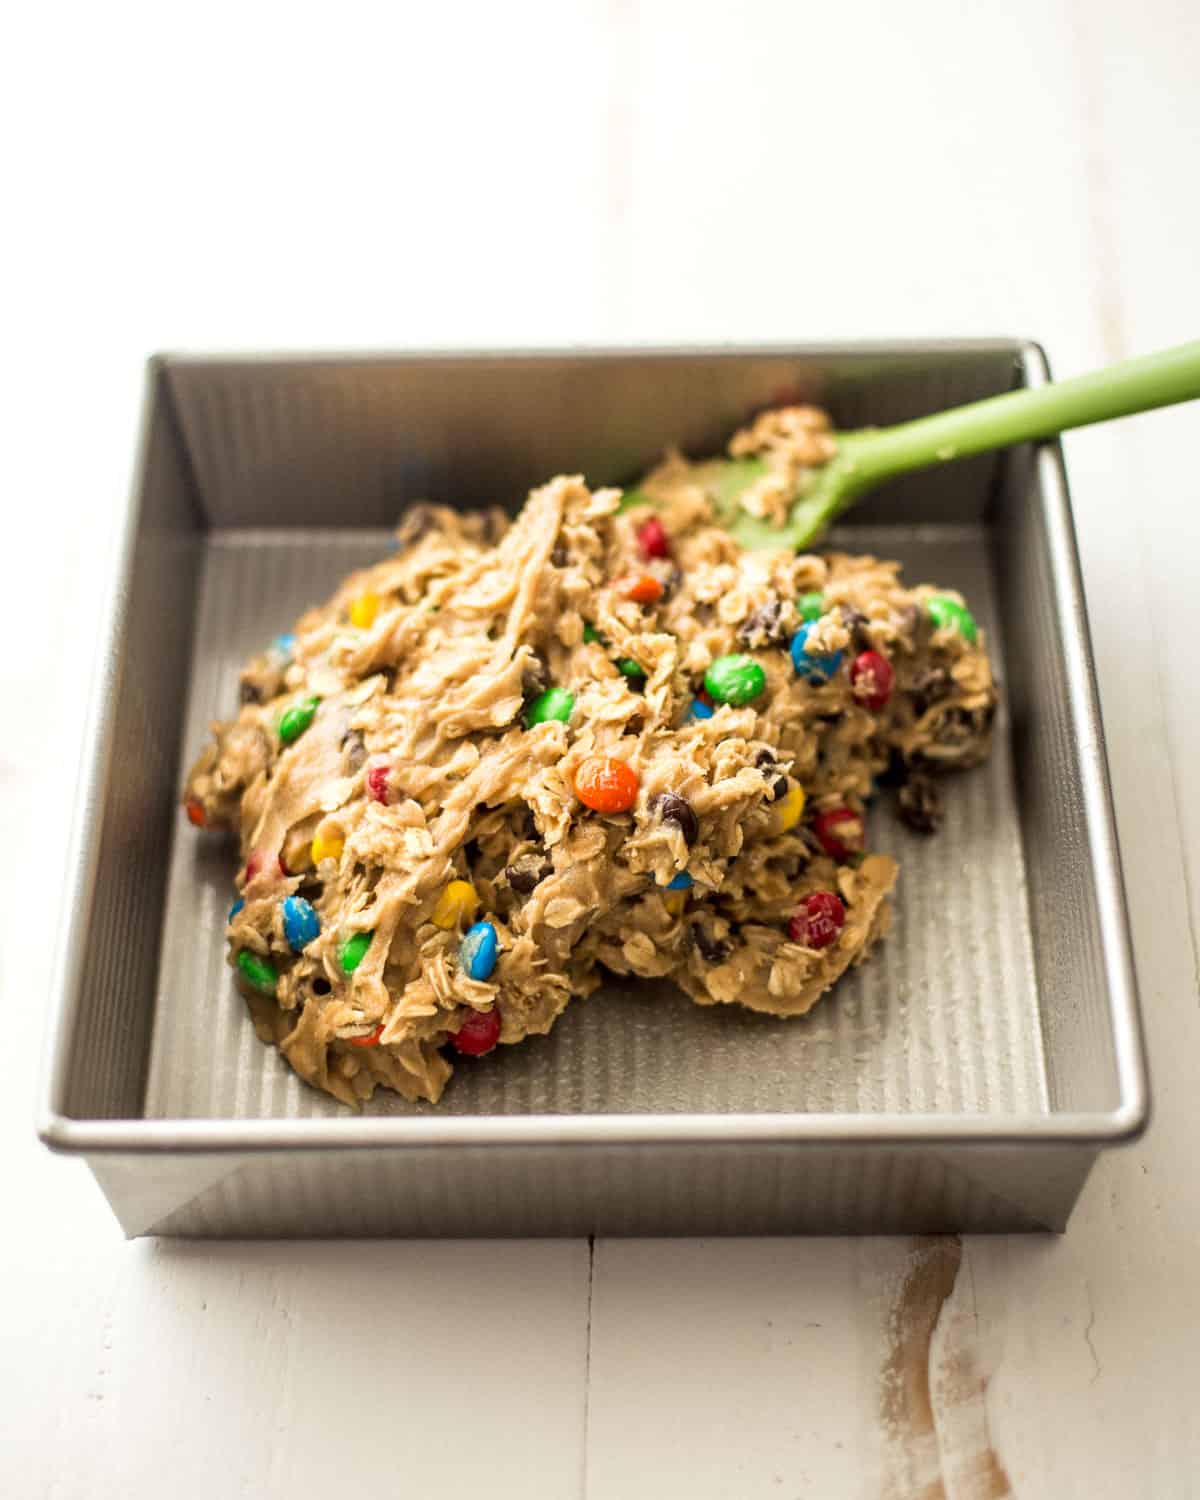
xmin=186 ymin=411 xmax=996 ymax=1104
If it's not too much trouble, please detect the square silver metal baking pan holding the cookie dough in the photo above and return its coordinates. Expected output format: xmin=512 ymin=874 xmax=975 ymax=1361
xmin=39 ymin=341 xmax=1148 ymax=1236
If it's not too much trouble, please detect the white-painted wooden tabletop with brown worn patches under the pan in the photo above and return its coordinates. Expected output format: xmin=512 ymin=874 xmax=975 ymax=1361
xmin=0 ymin=0 xmax=1200 ymax=1500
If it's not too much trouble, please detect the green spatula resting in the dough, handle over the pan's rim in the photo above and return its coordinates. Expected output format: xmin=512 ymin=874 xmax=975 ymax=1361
xmin=623 ymin=342 xmax=1200 ymax=549
